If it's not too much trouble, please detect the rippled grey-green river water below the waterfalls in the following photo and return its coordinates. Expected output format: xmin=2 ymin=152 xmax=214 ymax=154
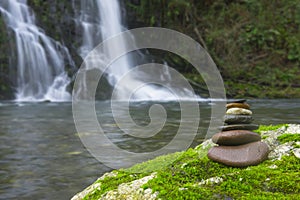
xmin=0 ymin=99 xmax=300 ymax=199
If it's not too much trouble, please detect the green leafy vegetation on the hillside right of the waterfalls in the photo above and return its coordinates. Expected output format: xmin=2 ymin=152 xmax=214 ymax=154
xmin=128 ymin=0 xmax=300 ymax=98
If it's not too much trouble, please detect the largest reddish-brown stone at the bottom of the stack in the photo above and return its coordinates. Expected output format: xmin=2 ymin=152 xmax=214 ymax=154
xmin=207 ymin=141 xmax=269 ymax=167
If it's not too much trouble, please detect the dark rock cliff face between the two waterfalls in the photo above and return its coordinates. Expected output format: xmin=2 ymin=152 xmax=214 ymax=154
xmin=28 ymin=0 xmax=82 ymax=73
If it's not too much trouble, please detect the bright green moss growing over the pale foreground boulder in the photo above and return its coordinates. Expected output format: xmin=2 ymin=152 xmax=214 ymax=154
xmin=79 ymin=124 xmax=300 ymax=200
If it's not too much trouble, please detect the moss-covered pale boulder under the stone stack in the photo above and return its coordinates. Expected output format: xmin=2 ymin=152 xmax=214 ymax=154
xmin=72 ymin=124 xmax=300 ymax=200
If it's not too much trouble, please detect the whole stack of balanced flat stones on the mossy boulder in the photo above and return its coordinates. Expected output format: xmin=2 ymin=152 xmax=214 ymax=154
xmin=208 ymin=99 xmax=269 ymax=167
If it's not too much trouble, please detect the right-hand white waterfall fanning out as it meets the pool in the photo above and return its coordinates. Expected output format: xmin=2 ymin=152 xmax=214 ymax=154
xmin=73 ymin=0 xmax=198 ymax=100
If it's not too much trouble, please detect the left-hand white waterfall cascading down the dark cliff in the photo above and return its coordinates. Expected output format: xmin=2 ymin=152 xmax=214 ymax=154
xmin=0 ymin=0 xmax=73 ymax=101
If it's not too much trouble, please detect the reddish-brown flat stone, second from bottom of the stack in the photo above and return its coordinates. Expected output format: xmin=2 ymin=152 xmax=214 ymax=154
xmin=212 ymin=130 xmax=261 ymax=145
